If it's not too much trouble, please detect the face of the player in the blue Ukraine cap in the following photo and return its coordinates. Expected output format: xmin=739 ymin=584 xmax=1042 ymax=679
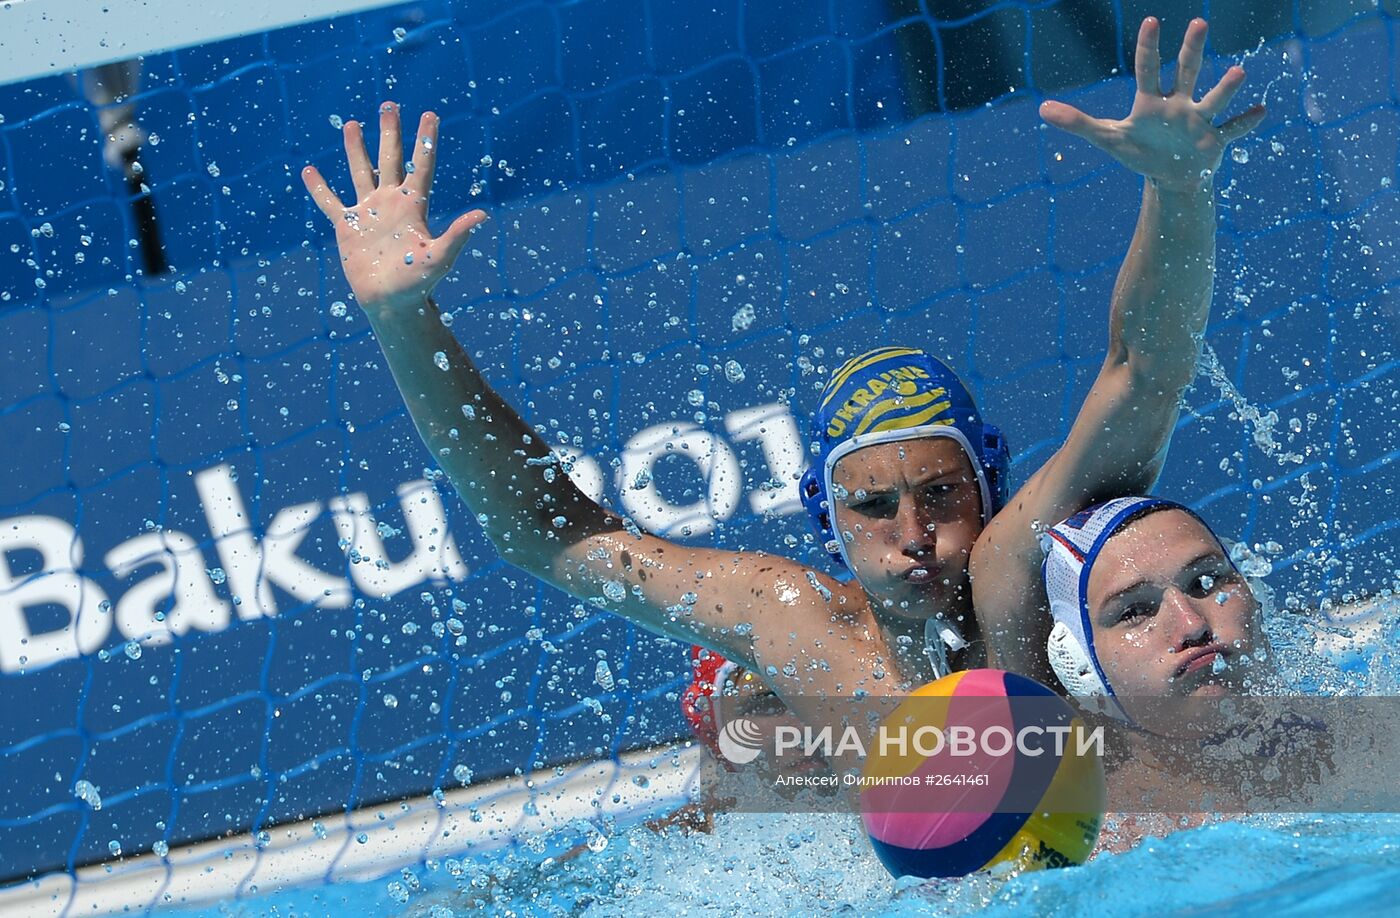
xmin=832 ymin=437 xmax=981 ymax=619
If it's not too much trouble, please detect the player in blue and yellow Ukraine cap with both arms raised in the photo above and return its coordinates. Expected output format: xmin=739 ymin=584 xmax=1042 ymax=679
xmin=304 ymin=20 xmax=1261 ymax=716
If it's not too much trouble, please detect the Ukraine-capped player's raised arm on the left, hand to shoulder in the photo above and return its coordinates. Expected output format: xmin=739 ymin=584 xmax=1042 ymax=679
xmin=302 ymin=104 xmax=857 ymax=691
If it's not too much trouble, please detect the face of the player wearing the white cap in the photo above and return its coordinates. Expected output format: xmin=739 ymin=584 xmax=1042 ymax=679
xmin=1086 ymin=509 xmax=1267 ymax=714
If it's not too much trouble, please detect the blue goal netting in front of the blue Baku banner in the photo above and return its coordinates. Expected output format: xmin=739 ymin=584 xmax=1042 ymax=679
xmin=0 ymin=0 xmax=1400 ymax=895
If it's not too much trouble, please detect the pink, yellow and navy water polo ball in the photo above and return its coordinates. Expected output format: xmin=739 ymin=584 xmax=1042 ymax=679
xmin=861 ymin=669 xmax=1105 ymax=877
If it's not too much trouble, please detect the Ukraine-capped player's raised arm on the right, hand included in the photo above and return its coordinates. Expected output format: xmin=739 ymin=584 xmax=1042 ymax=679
xmin=970 ymin=18 xmax=1264 ymax=682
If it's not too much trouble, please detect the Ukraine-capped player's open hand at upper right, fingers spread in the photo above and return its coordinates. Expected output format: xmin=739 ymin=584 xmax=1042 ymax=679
xmin=1040 ymin=17 xmax=1264 ymax=190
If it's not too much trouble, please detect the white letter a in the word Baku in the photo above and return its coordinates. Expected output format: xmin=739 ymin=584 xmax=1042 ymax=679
xmin=105 ymin=529 xmax=230 ymax=644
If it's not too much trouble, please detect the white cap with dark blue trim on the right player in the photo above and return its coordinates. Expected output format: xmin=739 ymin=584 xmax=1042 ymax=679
xmin=1040 ymin=497 xmax=1229 ymax=723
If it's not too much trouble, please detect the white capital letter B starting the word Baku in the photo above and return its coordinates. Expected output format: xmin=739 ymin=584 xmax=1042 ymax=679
xmin=0 ymin=516 xmax=112 ymax=673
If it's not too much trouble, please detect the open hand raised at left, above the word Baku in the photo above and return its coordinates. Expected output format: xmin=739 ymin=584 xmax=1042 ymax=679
xmin=301 ymin=102 xmax=486 ymax=311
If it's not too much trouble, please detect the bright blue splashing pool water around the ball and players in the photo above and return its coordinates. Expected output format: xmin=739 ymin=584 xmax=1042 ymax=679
xmin=186 ymin=602 xmax=1400 ymax=918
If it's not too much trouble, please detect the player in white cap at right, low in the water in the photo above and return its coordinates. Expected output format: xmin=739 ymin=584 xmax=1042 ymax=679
xmin=1044 ymin=497 xmax=1383 ymax=848
